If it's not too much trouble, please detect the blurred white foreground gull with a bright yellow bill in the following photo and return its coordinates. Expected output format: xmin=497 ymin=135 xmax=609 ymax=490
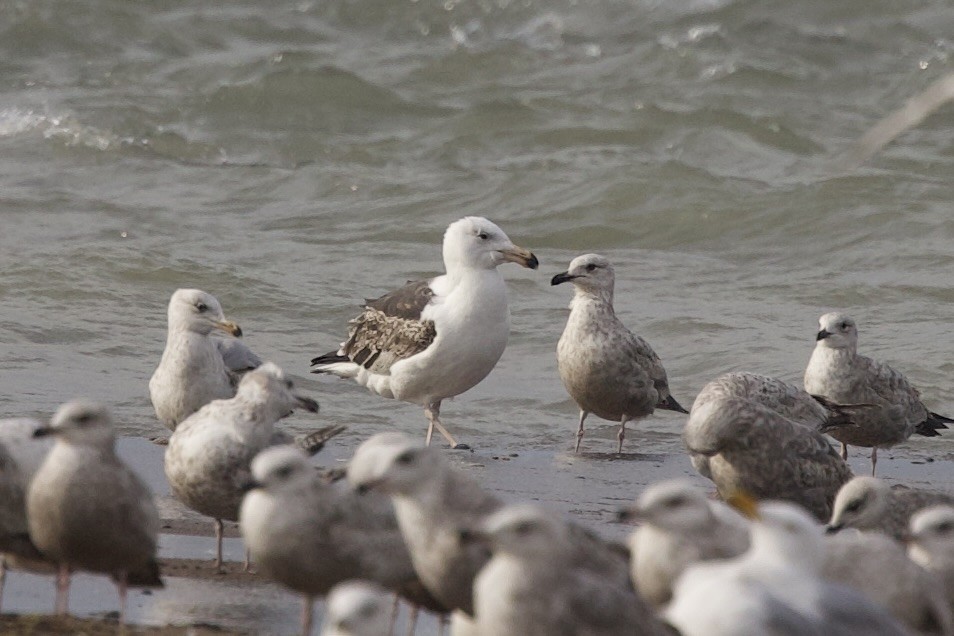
xmin=665 ymin=502 xmax=906 ymax=636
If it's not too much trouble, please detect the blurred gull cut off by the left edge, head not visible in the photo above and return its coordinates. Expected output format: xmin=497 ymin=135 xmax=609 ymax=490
xmin=0 ymin=418 xmax=53 ymax=612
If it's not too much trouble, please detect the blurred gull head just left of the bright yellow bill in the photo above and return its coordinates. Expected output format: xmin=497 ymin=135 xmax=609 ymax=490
xmin=619 ymin=479 xmax=715 ymax=534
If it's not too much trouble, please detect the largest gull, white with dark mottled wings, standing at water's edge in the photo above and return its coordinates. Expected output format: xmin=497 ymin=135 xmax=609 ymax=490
xmin=311 ymin=216 xmax=538 ymax=447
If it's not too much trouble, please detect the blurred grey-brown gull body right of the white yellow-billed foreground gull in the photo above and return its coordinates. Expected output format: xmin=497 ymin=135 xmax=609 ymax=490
xmin=821 ymin=532 xmax=954 ymax=635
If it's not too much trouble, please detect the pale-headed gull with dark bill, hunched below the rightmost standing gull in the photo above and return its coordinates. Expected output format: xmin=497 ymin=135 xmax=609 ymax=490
xmin=828 ymin=475 xmax=954 ymax=540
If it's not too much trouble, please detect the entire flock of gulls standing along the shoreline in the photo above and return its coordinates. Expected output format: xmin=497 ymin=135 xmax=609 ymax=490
xmin=0 ymin=217 xmax=954 ymax=636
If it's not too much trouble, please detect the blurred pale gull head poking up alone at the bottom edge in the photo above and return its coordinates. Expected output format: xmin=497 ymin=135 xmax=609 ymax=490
xmin=321 ymin=581 xmax=393 ymax=636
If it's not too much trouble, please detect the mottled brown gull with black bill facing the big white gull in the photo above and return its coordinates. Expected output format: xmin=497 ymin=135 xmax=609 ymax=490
xmin=550 ymin=254 xmax=689 ymax=454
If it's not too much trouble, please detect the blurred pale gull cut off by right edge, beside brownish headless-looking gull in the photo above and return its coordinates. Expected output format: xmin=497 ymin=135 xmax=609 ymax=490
xmin=907 ymin=504 xmax=954 ymax=607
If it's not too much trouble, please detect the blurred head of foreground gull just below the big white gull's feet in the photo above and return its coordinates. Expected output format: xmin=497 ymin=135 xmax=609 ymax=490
xmin=348 ymin=433 xmax=443 ymax=495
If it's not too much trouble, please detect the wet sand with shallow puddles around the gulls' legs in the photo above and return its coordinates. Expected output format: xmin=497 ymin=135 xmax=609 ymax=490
xmin=0 ymin=431 xmax=954 ymax=636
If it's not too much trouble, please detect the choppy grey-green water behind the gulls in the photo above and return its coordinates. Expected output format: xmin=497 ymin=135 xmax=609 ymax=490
xmin=0 ymin=0 xmax=954 ymax=456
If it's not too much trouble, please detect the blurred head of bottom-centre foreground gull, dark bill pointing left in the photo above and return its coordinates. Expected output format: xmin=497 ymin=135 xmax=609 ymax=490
xmin=460 ymin=504 xmax=570 ymax=560
